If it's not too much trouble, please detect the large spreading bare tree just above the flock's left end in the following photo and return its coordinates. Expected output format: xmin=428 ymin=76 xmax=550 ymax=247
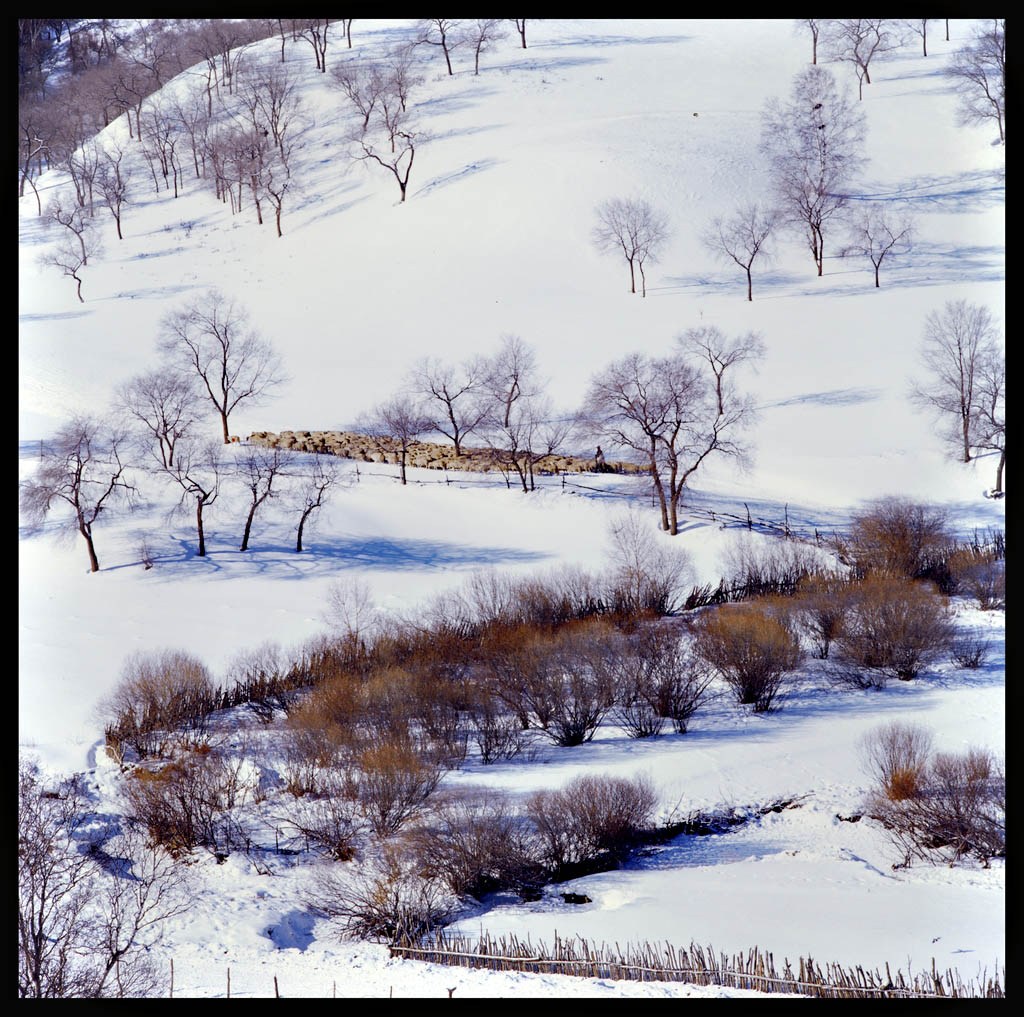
xmin=158 ymin=290 xmax=285 ymax=444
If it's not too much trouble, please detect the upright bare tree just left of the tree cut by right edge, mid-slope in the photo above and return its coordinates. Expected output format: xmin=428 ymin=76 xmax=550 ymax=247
xmin=910 ymin=300 xmax=999 ymax=463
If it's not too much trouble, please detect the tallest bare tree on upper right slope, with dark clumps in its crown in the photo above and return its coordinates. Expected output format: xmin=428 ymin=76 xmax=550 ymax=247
xmin=761 ymin=67 xmax=865 ymax=276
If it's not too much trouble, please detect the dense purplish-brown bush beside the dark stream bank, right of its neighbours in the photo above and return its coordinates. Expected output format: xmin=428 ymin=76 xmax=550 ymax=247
xmin=526 ymin=775 xmax=657 ymax=871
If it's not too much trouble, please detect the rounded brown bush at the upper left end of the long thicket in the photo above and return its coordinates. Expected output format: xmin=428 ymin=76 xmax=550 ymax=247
xmin=98 ymin=649 xmax=217 ymax=758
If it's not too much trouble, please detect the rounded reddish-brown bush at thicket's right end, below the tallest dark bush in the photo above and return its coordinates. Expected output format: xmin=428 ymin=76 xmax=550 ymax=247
xmin=835 ymin=576 xmax=955 ymax=687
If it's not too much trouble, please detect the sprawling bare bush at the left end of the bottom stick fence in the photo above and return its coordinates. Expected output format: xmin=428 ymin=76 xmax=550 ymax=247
xmin=302 ymin=845 xmax=453 ymax=943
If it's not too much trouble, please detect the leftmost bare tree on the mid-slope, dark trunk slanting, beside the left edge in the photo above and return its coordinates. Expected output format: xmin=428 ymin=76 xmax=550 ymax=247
xmin=20 ymin=415 xmax=135 ymax=573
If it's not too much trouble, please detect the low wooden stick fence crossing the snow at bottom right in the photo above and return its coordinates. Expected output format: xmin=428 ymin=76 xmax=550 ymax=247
xmin=390 ymin=932 xmax=1006 ymax=999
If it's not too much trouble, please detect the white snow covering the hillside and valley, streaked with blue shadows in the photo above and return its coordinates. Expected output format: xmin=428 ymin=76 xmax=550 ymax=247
xmin=18 ymin=20 xmax=1006 ymax=998
